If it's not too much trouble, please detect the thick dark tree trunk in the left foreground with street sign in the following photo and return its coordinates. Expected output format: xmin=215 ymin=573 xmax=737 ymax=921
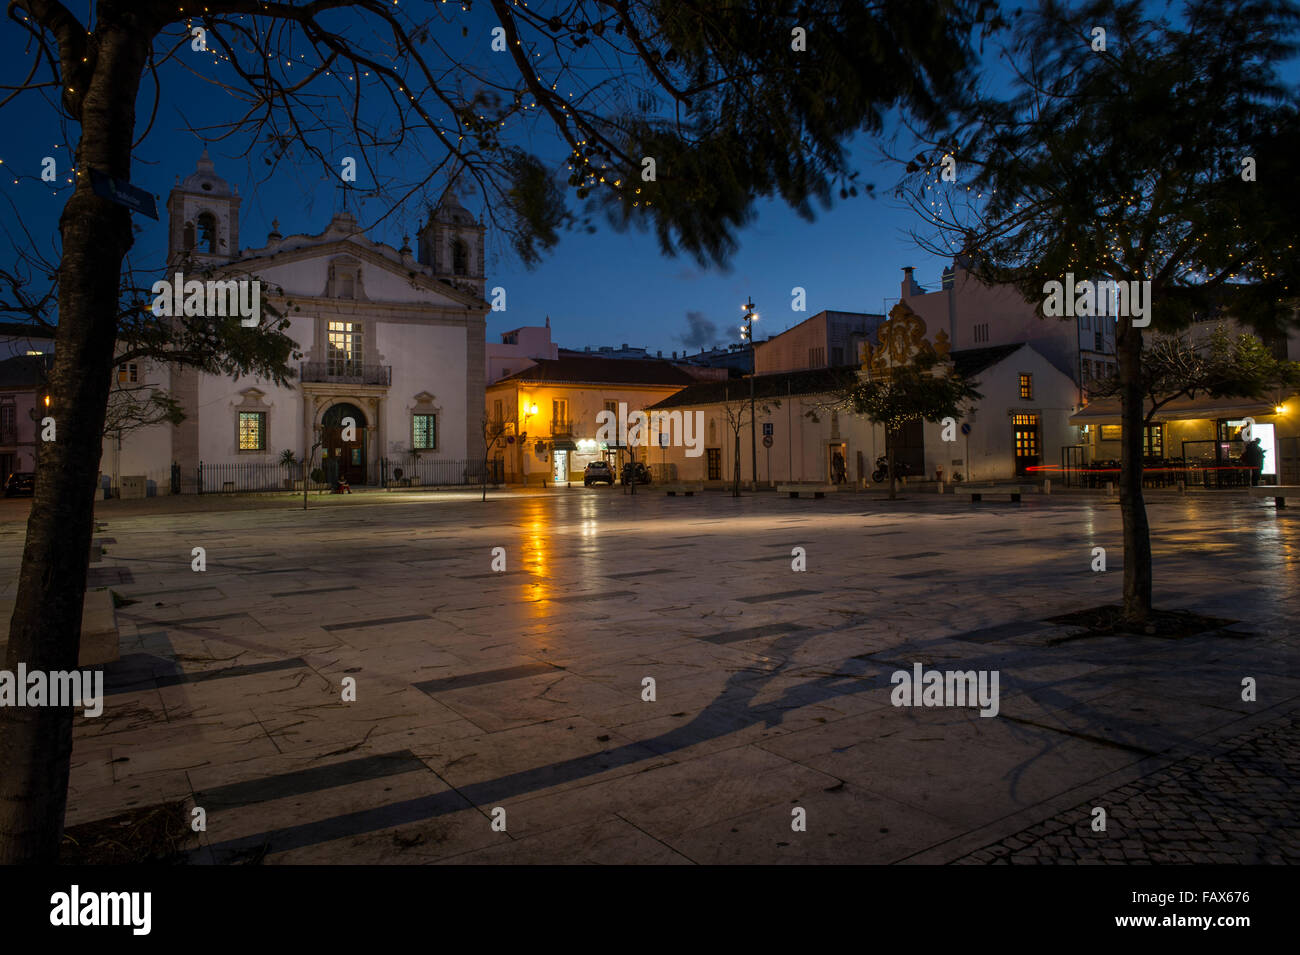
xmin=0 ymin=29 xmax=150 ymax=864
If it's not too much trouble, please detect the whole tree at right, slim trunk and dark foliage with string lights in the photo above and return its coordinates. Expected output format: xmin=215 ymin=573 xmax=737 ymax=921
xmin=900 ymin=0 xmax=1300 ymax=622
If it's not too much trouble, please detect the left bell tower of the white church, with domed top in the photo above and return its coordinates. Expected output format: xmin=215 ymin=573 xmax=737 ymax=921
xmin=166 ymin=149 xmax=239 ymax=265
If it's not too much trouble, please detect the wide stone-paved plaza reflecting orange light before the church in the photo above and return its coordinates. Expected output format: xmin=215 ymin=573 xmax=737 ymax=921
xmin=0 ymin=487 xmax=1300 ymax=864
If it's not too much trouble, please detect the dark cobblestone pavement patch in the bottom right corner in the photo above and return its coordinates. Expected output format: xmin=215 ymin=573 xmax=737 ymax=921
xmin=954 ymin=712 xmax=1300 ymax=865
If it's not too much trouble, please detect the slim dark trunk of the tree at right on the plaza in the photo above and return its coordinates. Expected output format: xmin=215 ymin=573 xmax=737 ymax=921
xmin=1115 ymin=318 xmax=1152 ymax=624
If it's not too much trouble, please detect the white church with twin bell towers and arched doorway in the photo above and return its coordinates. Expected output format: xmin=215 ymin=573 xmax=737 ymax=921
xmin=101 ymin=152 xmax=490 ymax=496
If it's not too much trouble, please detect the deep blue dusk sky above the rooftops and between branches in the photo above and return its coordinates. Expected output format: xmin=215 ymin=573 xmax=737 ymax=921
xmin=0 ymin=5 xmax=1294 ymax=356
